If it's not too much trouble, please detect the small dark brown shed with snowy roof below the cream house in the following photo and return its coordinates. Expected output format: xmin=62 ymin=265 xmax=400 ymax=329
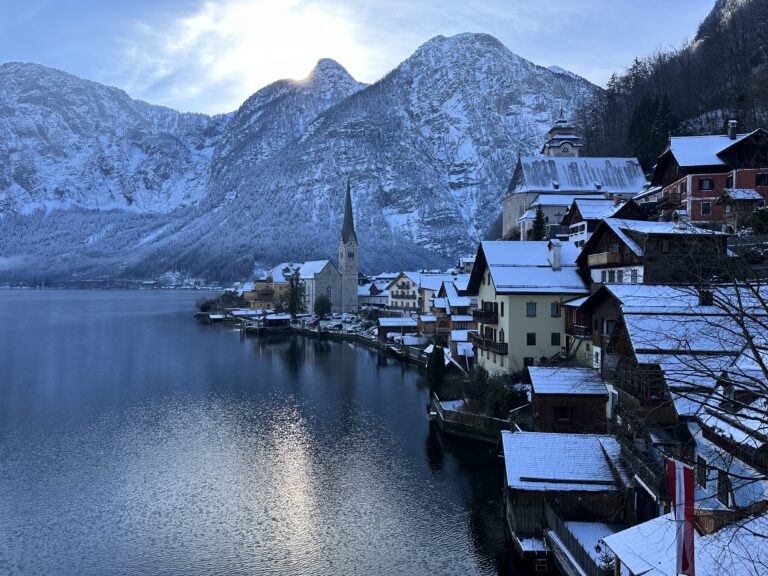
xmin=528 ymin=366 xmax=608 ymax=434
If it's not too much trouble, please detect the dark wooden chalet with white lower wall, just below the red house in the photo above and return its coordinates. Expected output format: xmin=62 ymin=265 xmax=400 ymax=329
xmin=577 ymin=218 xmax=728 ymax=285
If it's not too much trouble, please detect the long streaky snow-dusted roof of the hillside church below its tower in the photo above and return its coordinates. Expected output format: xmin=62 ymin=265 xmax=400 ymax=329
xmin=512 ymin=156 xmax=647 ymax=194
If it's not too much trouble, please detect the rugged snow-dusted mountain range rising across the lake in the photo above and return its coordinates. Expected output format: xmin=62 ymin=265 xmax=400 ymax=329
xmin=0 ymin=34 xmax=598 ymax=280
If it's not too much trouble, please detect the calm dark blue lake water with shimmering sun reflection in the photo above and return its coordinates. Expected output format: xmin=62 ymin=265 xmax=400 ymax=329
xmin=0 ymin=290 xmax=514 ymax=576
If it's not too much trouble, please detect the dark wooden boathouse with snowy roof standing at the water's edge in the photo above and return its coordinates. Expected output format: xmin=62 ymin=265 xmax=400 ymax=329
xmin=501 ymin=431 xmax=630 ymax=569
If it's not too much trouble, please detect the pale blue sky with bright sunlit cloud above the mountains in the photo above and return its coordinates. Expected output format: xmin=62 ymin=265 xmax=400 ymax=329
xmin=0 ymin=0 xmax=714 ymax=114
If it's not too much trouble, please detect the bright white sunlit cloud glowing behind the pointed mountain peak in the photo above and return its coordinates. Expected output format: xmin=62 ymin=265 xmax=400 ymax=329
xmin=114 ymin=0 xmax=372 ymax=113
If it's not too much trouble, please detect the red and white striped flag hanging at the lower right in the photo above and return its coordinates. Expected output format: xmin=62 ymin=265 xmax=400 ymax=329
xmin=667 ymin=458 xmax=696 ymax=576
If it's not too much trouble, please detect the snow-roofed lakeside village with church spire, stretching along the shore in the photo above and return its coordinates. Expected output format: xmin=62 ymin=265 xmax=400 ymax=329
xmin=197 ymin=116 xmax=768 ymax=576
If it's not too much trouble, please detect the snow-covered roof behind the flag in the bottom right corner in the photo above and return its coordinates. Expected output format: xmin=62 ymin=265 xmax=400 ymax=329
xmin=603 ymin=513 xmax=768 ymax=576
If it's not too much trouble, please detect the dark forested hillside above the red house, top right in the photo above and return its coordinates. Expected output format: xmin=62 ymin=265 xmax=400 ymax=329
xmin=576 ymin=0 xmax=768 ymax=170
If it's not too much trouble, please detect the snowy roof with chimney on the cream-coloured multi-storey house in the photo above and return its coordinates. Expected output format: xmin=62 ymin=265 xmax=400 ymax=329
xmin=472 ymin=241 xmax=589 ymax=294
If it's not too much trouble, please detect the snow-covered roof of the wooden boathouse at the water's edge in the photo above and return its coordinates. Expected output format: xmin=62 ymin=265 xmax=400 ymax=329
xmin=501 ymin=430 xmax=628 ymax=492
